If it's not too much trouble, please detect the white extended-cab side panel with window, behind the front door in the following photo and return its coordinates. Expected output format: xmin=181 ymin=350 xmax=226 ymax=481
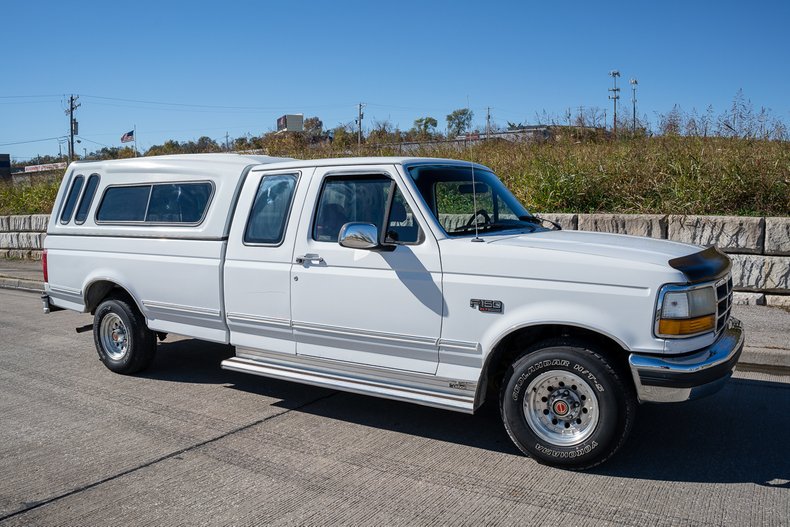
xmin=223 ymin=168 xmax=313 ymax=355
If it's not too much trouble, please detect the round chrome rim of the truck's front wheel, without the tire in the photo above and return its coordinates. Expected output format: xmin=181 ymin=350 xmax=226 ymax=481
xmin=523 ymin=370 xmax=599 ymax=446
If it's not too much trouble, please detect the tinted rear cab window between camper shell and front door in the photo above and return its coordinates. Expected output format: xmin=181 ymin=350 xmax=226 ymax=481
xmin=244 ymin=174 xmax=296 ymax=245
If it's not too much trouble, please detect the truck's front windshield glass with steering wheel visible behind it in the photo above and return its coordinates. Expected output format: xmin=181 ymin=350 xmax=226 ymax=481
xmin=408 ymin=165 xmax=542 ymax=236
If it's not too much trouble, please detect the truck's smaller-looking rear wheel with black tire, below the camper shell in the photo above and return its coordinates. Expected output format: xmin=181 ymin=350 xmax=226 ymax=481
xmin=93 ymin=298 xmax=156 ymax=375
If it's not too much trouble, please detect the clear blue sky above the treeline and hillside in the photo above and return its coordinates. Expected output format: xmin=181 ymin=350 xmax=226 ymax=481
xmin=0 ymin=0 xmax=790 ymax=158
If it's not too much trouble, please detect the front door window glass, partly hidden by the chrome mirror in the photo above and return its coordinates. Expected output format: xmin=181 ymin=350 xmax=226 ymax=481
xmin=313 ymin=175 xmax=421 ymax=243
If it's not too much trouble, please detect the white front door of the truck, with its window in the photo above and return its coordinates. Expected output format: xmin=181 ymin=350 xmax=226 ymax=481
xmin=291 ymin=165 xmax=443 ymax=373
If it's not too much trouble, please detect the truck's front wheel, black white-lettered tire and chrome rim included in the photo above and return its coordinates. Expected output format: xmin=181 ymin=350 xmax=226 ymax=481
xmin=499 ymin=340 xmax=637 ymax=470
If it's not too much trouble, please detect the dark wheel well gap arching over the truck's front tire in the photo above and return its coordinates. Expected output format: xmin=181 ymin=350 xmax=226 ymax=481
xmin=475 ymin=324 xmax=633 ymax=408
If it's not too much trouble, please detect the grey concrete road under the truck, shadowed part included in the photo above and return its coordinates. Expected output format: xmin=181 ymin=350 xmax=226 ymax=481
xmin=0 ymin=290 xmax=790 ymax=526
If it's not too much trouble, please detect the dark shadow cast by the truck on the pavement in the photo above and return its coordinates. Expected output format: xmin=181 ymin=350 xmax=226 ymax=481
xmin=141 ymin=340 xmax=790 ymax=489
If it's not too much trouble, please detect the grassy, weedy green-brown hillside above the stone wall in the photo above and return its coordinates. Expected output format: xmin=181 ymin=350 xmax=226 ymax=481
xmin=0 ymin=135 xmax=790 ymax=216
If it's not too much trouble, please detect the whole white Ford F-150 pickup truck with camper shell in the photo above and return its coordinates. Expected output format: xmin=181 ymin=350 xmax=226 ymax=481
xmin=42 ymin=154 xmax=743 ymax=469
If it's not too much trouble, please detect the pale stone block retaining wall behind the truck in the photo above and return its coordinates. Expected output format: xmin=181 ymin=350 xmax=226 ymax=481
xmin=0 ymin=213 xmax=790 ymax=304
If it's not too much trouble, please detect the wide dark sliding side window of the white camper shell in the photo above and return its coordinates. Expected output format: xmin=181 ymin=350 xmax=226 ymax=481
xmin=96 ymin=181 xmax=214 ymax=225
